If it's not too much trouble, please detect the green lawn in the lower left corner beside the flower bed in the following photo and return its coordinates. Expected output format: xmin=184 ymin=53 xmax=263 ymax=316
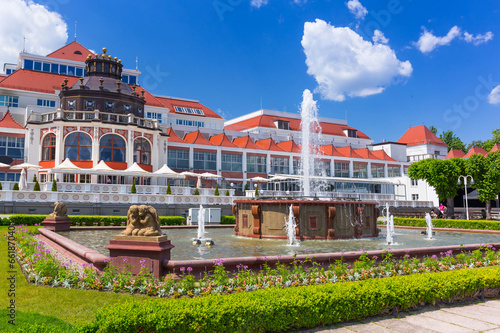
xmin=0 ymin=226 xmax=147 ymax=332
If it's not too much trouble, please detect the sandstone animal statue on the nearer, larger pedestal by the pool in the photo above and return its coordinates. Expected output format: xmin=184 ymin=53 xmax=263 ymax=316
xmin=121 ymin=205 xmax=162 ymax=236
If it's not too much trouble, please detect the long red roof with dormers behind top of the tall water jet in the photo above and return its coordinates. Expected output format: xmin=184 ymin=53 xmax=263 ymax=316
xmin=226 ymin=115 xmax=370 ymax=139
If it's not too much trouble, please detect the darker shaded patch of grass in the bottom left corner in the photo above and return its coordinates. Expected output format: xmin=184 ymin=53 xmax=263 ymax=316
xmin=0 ymin=309 xmax=75 ymax=333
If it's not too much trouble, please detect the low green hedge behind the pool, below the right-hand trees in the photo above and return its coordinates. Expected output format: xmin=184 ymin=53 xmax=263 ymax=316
xmin=394 ymin=217 xmax=500 ymax=230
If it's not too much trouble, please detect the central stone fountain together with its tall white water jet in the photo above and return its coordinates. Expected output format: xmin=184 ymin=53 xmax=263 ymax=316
xmin=233 ymin=89 xmax=379 ymax=240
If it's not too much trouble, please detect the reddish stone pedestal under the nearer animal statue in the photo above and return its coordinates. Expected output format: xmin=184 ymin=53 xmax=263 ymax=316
xmin=106 ymin=235 xmax=174 ymax=278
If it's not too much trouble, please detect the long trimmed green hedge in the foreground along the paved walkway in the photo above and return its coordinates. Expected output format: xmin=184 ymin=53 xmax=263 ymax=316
xmin=80 ymin=267 xmax=500 ymax=333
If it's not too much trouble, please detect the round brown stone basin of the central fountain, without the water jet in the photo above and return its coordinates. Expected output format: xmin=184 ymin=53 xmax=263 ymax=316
xmin=233 ymin=199 xmax=379 ymax=240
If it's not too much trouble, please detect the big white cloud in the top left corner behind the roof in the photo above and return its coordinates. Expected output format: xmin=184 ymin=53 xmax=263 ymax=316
xmin=0 ymin=0 xmax=68 ymax=68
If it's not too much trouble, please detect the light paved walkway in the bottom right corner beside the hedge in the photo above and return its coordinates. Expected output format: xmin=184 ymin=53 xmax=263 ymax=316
xmin=294 ymin=298 xmax=500 ymax=333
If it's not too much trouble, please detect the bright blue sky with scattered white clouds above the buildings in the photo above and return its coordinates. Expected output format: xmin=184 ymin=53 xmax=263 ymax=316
xmin=0 ymin=0 xmax=500 ymax=143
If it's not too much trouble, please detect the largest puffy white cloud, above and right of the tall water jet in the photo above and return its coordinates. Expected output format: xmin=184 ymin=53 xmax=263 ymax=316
xmin=302 ymin=19 xmax=413 ymax=101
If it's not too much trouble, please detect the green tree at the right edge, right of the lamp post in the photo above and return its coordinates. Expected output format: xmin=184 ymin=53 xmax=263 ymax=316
xmin=462 ymin=151 xmax=500 ymax=220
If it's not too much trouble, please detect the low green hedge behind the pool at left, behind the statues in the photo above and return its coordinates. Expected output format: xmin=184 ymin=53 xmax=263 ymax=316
xmin=1 ymin=214 xmax=186 ymax=226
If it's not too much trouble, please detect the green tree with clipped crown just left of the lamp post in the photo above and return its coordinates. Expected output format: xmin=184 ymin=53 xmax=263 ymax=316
xmin=408 ymin=158 xmax=465 ymax=218
